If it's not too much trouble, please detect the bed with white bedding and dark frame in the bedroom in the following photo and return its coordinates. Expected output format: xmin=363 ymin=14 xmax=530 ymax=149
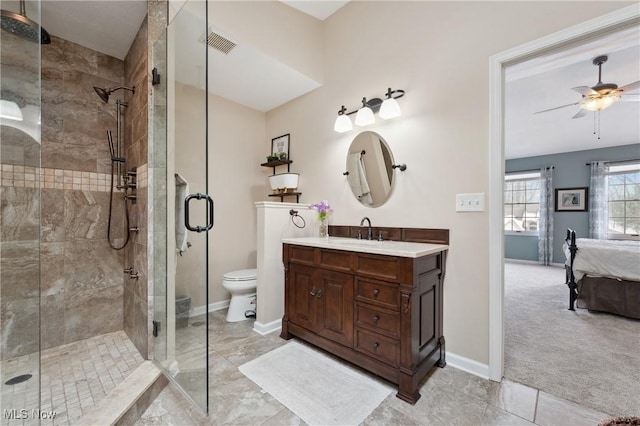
xmin=564 ymin=229 xmax=640 ymax=319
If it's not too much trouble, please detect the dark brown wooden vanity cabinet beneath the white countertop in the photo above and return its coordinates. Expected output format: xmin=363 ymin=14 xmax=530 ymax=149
xmin=281 ymin=244 xmax=446 ymax=404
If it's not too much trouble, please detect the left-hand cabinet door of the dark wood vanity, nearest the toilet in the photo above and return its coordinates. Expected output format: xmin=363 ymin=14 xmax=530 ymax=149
xmin=287 ymin=263 xmax=318 ymax=331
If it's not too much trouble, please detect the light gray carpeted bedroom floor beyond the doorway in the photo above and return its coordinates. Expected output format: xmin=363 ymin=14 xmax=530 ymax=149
xmin=504 ymin=263 xmax=640 ymax=416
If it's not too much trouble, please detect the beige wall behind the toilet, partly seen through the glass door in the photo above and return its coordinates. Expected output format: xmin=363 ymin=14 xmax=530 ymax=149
xmin=175 ymin=83 xmax=270 ymax=308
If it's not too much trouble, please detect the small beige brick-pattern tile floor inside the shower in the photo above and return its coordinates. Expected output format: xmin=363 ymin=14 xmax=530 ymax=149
xmin=0 ymin=331 xmax=143 ymax=426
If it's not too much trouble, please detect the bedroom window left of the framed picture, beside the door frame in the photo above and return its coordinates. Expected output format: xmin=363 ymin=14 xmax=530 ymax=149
xmin=504 ymin=172 xmax=540 ymax=235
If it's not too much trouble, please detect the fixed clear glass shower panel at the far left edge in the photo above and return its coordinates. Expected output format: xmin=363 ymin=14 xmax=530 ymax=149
xmin=0 ymin=1 xmax=41 ymax=425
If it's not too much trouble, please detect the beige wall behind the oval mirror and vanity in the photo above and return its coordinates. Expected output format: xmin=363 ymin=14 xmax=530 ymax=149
xmin=266 ymin=1 xmax=630 ymax=364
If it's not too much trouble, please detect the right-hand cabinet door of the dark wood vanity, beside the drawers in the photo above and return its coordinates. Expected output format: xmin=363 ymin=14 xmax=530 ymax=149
xmin=316 ymin=269 xmax=353 ymax=347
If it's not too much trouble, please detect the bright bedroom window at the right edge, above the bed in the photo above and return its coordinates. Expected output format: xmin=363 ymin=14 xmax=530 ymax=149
xmin=607 ymin=163 xmax=640 ymax=238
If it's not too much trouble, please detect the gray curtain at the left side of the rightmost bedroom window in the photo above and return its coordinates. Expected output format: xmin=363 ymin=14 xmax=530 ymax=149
xmin=589 ymin=161 xmax=609 ymax=240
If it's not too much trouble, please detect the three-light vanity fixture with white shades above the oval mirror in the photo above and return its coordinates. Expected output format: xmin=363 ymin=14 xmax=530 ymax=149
xmin=333 ymin=88 xmax=404 ymax=133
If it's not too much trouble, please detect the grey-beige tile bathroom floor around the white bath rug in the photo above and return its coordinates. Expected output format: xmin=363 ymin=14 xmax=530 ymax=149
xmin=136 ymin=311 xmax=611 ymax=426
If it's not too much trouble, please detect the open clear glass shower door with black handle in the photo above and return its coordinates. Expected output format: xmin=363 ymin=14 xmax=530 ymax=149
xmin=153 ymin=0 xmax=213 ymax=412
